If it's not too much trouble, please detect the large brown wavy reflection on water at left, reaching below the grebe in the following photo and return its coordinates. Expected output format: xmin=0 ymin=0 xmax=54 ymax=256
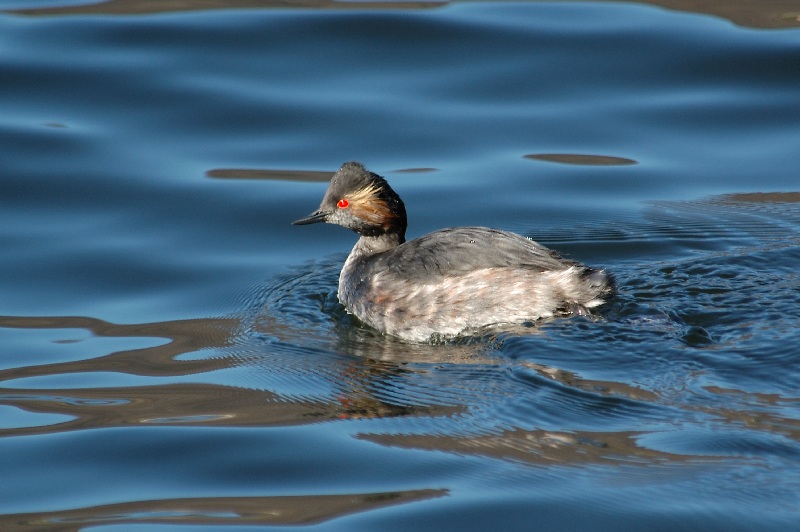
xmin=0 ymin=317 xmax=452 ymax=436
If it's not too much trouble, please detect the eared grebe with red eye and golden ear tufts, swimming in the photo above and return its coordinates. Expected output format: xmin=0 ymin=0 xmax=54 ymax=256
xmin=294 ymin=162 xmax=613 ymax=341
